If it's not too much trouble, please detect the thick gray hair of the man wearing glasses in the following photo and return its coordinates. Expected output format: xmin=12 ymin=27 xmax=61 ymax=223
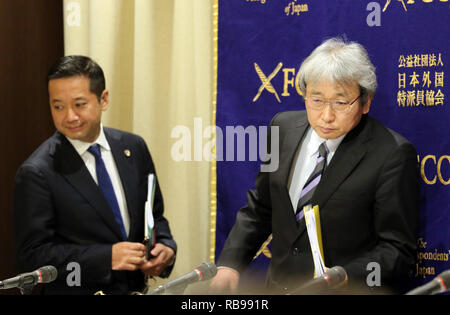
xmin=298 ymin=37 xmax=377 ymax=104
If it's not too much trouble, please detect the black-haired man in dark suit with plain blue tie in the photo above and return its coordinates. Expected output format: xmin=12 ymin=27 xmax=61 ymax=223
xmin=14 ymin=56 xmax=177 ymax=294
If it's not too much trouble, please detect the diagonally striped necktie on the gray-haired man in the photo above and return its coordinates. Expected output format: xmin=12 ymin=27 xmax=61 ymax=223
xmin=295 ymin=142 xmax=329 ymax=221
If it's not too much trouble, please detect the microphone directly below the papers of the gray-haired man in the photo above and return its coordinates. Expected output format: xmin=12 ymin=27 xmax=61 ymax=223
xmin=290 ymin=266 xmax=347 ymax=294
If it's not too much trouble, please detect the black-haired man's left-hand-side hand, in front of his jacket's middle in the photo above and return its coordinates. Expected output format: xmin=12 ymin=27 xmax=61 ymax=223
xmin=112 ymin=242 xmax=146 ymax=271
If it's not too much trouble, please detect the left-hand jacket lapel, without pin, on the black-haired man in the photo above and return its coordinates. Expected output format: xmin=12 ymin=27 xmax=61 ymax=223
xmin=51 ymin=134 xmax=122 ymax=240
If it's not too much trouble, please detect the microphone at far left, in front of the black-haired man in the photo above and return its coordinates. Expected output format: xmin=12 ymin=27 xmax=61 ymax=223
xmin=0 ymin=266 xmax=58 ymax=290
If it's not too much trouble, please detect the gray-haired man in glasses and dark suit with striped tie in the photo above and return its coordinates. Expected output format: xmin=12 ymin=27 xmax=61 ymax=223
xmin=211 ymin=38 xmax=419 ymax=293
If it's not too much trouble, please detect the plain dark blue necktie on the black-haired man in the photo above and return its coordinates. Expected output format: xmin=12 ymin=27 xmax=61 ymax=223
xmin=88 ymin=144 xmax=127 ymax=239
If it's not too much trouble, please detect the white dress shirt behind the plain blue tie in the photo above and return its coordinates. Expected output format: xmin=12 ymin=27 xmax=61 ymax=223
xmin=66 ymin=125 xmax=130 ymax=235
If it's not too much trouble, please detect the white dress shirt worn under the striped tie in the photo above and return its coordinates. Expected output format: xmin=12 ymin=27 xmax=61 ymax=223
xmin=289 ymin=127 xmax=345 ymax=212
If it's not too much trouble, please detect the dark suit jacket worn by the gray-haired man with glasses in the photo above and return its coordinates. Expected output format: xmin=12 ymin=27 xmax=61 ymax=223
xmin=218 ymin=111 xmax=419 ymax=290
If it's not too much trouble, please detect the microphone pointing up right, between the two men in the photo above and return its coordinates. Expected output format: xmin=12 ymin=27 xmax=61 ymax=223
xmin=146 ymin=262 xmax=217 ymax=295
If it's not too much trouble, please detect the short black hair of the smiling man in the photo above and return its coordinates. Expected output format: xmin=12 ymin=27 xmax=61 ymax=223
xmin=47 ymin=55 xmax=106 ymax=102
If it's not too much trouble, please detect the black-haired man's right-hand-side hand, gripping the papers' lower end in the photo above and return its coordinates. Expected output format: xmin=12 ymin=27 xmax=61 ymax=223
xmin=139 ymin=243 xmax=175 ymax=277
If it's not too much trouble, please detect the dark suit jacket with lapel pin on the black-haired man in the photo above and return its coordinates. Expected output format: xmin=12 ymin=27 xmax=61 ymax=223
xmin=14 ymin=128 xmax=176 ymax=294
